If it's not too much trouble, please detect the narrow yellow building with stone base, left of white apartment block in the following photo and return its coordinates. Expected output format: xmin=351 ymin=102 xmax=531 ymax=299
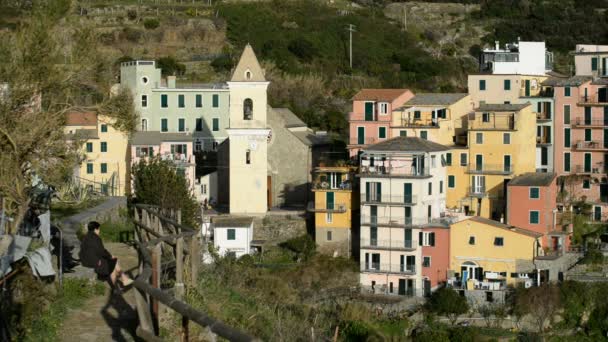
xmin=308 ymin=166 xmax=359 ymax=257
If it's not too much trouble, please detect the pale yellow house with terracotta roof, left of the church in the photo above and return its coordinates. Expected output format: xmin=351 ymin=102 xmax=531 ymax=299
xmin=64 ymin=112 xmax=129 ymax=196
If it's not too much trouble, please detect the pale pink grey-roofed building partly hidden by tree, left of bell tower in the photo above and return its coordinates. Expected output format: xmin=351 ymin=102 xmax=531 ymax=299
xmin=131 ymin=131 xmax=196 ymax=191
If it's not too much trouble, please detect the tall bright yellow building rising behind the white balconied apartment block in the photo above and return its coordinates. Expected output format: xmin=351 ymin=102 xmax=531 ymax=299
xmin=446 ymin=104 xmax=536 ymax=220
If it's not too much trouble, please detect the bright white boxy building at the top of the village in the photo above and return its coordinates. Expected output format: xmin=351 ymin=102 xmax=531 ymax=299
xmin=480 ymin=41 xmax=553 ymax=75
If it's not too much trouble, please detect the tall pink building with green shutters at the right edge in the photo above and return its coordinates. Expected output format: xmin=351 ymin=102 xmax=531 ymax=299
xmin=555 ymin=76 xmax=608 ymax=221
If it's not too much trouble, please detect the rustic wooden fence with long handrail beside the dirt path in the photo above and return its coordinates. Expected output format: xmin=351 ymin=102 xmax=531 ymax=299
xmin=133 ymin=204 xmax=256 ymax=341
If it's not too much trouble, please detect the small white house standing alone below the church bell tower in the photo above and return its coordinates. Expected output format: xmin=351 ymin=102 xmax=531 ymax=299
xmin=211 ymin=216 xmax=253 ymax=258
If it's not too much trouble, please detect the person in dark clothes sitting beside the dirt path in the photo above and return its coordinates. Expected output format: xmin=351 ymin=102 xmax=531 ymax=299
xmin=80 ymin=221 xmax=133 ymax=286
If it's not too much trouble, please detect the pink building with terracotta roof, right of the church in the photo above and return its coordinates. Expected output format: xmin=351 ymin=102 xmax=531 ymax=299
xmin=348 ymin=89 xmax=414 ymax=157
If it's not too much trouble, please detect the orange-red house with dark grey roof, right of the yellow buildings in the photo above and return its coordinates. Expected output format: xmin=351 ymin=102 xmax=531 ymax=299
xmin=507 ymin=172 xmax=571 ymax=255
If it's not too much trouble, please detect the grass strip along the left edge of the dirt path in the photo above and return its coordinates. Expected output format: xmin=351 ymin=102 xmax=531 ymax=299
xmin=23 ymin=278 xmax=105 ymax=342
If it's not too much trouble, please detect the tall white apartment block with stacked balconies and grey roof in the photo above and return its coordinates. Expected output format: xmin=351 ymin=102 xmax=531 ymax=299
xmin=359 ymin=137 xmax=448 ymax=296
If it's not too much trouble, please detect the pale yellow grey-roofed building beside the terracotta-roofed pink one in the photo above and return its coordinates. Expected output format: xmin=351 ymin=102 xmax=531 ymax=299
xmin=391 ymin=93 xmax=473 ymax=145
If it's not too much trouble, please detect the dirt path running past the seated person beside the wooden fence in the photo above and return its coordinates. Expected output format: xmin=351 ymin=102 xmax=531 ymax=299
xmin=59 ymin=243 xmax=139 ymax=342
